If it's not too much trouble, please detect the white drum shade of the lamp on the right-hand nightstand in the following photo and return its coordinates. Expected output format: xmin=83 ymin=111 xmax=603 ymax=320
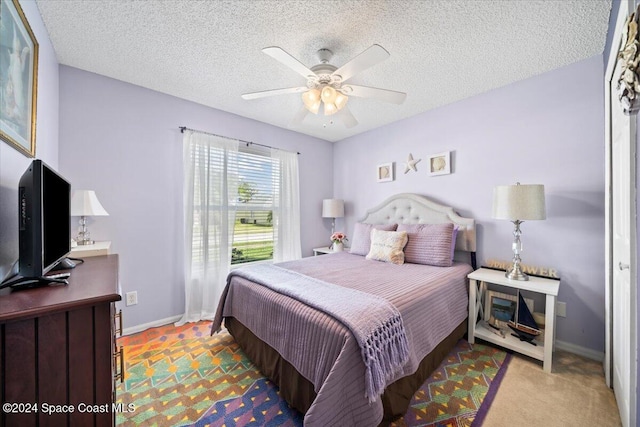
xmin=493 ymin=183 xmax=547 ymax=221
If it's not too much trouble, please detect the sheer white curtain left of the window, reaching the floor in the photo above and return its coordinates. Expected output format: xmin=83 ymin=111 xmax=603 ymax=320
xmin=176 ymin=130 xmax=238 ymax=325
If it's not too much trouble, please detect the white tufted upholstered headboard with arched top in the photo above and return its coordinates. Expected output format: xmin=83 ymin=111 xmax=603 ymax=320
xmin=360 ymin=193 xmax=476 ymax=263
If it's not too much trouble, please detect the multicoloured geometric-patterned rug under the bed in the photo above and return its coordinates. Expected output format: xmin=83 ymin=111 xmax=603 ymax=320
xmin=116 ymin=322 xmax=511 ymax=427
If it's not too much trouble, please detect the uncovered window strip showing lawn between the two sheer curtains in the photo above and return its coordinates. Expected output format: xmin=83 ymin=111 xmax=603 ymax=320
xmin=231 ymin=149 xmax=280 ymax=265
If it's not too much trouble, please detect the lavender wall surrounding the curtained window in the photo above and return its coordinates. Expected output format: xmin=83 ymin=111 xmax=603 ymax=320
xmin=60 ymin=66 xmax=333 ymax=328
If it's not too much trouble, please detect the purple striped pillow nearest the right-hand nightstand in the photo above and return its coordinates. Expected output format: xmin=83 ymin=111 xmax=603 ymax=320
xmin=398 ymin=223 xmax=453 ymax=267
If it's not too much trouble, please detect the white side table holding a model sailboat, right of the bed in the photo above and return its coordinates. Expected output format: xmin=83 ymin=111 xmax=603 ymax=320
xmin=467 ymin=268 xmax=560 ymax=372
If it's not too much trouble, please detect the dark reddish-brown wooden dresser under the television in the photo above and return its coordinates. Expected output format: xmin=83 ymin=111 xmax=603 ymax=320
xmin=0 ymin=255 xmax=122 ymax=427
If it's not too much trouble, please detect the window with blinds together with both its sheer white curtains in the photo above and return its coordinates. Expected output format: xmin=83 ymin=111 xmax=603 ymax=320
xmin=179 ymin=129 xmax=301 ymax=324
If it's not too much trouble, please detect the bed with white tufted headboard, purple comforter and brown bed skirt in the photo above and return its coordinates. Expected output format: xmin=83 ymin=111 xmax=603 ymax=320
xmin=212 ymin=194 xmax=476 ymax=426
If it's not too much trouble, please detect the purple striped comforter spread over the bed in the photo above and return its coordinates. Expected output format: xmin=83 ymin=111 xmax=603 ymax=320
xmin=214 ymin=253 xmax=471 ymax=426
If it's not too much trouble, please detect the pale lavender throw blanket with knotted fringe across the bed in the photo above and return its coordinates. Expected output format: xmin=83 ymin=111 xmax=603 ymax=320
xmin=213 ymin=264 xmax=409 ymax=402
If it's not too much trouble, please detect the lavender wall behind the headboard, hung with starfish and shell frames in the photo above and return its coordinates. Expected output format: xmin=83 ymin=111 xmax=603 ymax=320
xmin=334 ymin=55 xmax=605 ymax=352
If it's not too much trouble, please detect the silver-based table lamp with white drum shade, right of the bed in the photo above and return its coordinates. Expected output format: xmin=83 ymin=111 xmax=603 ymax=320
xmin=493 ymin=182 xmax=546 ymax=280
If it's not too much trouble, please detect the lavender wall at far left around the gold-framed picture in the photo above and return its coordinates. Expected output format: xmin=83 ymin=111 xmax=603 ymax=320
xmin=0 ymin=1 xmax=58 ymax=281
